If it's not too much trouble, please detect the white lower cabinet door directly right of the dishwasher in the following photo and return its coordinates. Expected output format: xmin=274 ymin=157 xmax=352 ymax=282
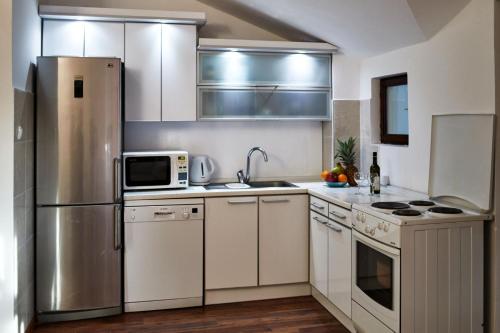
xmin=205 ymin=197 xmax=258 ymax=289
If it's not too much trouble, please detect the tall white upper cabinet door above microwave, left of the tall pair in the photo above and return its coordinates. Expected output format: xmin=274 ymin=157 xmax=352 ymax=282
xmin=125 ymin=23 xmax=162 ymax=121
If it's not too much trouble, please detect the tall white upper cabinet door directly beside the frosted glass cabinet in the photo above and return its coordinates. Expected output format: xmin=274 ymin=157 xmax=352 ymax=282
xmin=162 ymin=24 xmax=196 ymax=121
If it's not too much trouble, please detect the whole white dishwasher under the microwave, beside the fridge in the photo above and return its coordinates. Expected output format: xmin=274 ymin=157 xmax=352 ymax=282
xmin=124 ymin=199 xmax=204 ymax=312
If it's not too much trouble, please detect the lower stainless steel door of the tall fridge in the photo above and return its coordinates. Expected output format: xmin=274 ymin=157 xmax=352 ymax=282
xmin=36 ymin=205 xmax=122 ymax=313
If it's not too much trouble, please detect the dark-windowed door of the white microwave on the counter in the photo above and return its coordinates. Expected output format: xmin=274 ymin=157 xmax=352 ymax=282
xmin=123 ymin=155 xmax=173 ymax=190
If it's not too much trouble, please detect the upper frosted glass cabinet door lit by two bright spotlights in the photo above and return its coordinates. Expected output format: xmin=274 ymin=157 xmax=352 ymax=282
xmin=198 ymin=51 xmax=331 ymax=88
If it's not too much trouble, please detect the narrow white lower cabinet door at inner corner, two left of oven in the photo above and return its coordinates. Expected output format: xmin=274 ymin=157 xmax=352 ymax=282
xmin=309 ymin=211 xmax=328 ymax=297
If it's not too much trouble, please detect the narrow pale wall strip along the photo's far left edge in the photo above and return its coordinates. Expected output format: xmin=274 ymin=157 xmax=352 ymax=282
xmin=0 ymin=0 xmax=17 ymax=333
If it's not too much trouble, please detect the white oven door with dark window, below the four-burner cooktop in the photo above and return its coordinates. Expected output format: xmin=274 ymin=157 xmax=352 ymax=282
xmin=352 ymin=230 xmax=401 ymax=332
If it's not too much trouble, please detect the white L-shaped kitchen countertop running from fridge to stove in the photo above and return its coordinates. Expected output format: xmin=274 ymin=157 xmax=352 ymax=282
xmin=124 ymin=182 xmax=428 ymax=209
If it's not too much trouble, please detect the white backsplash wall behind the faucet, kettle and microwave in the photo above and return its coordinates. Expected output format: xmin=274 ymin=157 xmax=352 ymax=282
xmin=125 ymin=121 xmax=322 ymax=180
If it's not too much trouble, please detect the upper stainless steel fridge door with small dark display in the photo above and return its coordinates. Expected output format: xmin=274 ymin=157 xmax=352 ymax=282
xmin=36 ymin=57 xmax=121 ymax=205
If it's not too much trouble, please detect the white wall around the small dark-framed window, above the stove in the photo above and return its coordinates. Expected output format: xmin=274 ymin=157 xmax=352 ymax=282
xmin=360 ymin=0 xmax=495 ymax=192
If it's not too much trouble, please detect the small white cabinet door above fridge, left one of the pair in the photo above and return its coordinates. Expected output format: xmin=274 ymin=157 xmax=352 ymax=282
xmin=42 ymin=20 xmax=85 ymax=57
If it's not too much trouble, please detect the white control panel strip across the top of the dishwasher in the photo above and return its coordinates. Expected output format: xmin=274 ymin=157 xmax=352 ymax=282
xmin=124 ymin=205 xmax=203 ymax=223
